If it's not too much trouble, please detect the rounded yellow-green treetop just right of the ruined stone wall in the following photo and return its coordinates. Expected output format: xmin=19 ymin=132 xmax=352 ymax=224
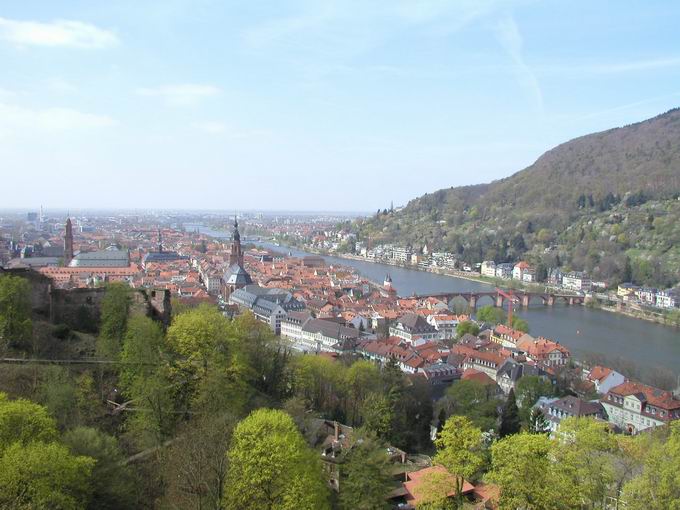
xmin=168 ymin=305 xmax=231 ymax=371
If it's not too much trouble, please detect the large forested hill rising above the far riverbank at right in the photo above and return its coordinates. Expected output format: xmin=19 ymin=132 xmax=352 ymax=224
xmin=357 ymin=109 xmax=680 ymax=285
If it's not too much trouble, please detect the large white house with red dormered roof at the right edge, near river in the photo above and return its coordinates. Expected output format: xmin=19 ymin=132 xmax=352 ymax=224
xmin=601 ymin=381 xmax=680 ymax=434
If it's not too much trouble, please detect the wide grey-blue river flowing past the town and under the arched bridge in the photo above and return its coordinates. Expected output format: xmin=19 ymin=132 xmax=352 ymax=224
xmin=191 ymin=228 xmax=680 ymax=378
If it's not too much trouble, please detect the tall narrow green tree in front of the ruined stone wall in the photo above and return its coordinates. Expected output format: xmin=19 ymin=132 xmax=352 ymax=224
xmin=97 ymin=282 xmax=131 ymax=359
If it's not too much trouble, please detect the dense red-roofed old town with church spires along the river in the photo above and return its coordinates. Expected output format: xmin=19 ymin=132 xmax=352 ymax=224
xmin=0 ymin=209 xmax=680 ymax=508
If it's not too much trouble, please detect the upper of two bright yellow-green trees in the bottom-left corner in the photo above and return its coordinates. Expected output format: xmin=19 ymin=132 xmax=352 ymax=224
xmin=0 ymin=393 xmax=57 ymax=454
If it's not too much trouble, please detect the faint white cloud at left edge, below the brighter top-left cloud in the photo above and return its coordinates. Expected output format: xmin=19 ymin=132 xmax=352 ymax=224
xmin=0 ymin=103 xmax=117 ymax=136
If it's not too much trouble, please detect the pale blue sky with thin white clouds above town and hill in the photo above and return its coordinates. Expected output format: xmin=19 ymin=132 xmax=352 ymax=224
xmin=0 ymin=0 xmax=680 ymax=211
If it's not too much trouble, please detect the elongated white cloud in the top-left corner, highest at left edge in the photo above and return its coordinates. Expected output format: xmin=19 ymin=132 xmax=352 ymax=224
xmin=0 ymin=18 xmax=119 ymax=49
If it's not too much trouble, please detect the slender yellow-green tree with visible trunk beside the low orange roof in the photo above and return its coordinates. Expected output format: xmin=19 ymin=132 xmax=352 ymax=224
xmin=434 ymin=416 xmax=484 ymax=505
